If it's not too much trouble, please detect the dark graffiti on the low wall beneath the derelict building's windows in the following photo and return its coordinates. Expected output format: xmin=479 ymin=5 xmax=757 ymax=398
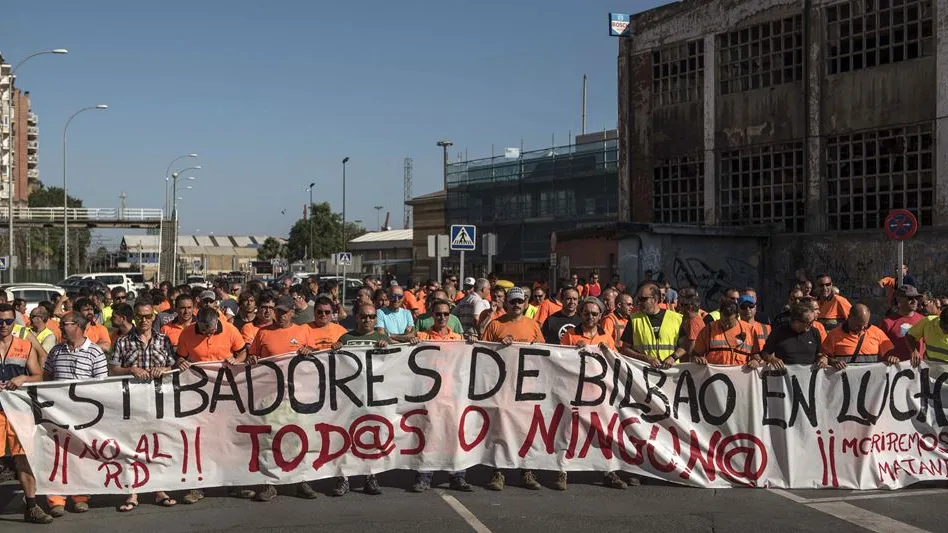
xmin=670 ymin=256 xmax=759 ymax=309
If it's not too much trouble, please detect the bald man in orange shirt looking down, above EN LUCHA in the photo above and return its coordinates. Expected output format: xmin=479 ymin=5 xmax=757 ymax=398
xmin=821 ymin=304 xmax=899 ymax=370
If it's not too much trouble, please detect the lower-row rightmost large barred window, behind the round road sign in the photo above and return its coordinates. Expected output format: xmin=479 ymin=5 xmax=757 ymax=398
xmin=826 ymin=123 xmax=935 ymax=230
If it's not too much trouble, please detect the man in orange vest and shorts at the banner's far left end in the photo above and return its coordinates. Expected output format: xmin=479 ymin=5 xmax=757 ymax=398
xmin=0 ymin=304 xmax=53 ymax=524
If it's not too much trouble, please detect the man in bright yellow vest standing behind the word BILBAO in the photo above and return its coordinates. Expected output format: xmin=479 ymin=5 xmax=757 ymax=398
xmin=619 ymin=282 xmax=688 ymax=368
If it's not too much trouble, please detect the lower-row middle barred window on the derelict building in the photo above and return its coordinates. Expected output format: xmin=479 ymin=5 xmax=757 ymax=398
xmin=718 ymin=141 xmax=806 ymax=232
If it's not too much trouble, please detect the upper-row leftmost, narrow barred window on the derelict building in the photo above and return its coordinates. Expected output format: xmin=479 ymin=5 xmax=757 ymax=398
xmin=652 ymin=40 xmax=704 ymax=107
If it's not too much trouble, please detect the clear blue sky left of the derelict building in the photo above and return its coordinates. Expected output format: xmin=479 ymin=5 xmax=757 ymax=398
xmin=0 ymin=0 xmax=655 ymax=241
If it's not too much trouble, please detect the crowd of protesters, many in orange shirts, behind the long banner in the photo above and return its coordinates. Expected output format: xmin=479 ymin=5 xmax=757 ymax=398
xmin=0 ymin=266 xmax=948 ymax=524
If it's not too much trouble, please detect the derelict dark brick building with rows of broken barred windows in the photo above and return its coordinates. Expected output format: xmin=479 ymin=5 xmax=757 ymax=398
xmin=561 ymin=0 xmax=948 ymax=310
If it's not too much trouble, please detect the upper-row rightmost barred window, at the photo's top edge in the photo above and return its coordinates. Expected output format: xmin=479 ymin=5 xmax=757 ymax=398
xmin=826 ymin=0 xmax=935 ymax=74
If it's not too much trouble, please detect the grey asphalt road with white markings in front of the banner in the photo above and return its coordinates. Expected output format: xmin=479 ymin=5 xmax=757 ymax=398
xmin=0 ymin=468 xmax=948 ymax=533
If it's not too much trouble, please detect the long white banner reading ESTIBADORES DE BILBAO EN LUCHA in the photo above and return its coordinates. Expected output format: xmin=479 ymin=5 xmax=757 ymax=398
xmin=0 ymin=343 xmax=948 ymax=494
